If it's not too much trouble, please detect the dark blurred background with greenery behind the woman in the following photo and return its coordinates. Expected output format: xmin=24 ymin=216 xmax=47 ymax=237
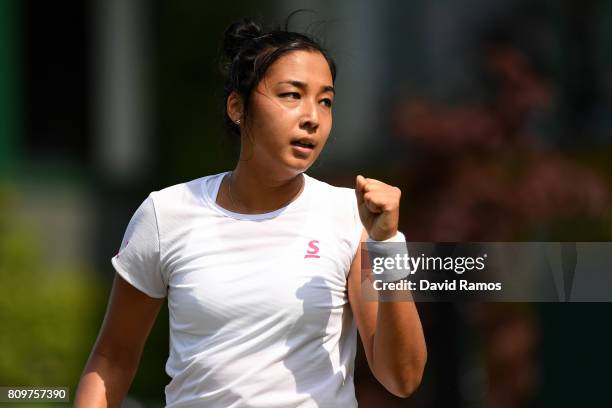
xmin=0 ymin=0 xmax=612 ymax=407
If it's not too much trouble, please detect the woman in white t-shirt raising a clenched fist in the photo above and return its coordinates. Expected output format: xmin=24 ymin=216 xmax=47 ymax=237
xmin=75 ymin=19 xmax=426 ymax=407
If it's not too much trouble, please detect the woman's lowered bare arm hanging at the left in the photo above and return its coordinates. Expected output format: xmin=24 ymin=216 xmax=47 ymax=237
xmin=74 ymin=274 xmax=164 ymax=408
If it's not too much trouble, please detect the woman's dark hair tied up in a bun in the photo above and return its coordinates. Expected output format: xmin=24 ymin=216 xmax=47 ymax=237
xmin=221 ymin=12 xmax=336 ymax=135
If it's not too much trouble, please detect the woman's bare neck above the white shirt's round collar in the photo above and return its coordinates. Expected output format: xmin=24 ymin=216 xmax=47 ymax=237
xmin=226 ymin=162 xmax=305 ymax=214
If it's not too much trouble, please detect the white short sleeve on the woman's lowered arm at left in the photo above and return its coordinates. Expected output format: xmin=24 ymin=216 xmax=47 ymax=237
xmin=111 ymin=195 xmax=168 ymax=298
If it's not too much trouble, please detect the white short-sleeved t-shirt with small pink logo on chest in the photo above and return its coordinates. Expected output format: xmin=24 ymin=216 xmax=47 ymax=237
xmin=112 ymin=173 xmax=363 ymax=408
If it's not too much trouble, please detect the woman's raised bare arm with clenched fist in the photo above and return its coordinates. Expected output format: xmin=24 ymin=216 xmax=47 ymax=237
xmin=348 ymin=175 xmax=427 ymax=397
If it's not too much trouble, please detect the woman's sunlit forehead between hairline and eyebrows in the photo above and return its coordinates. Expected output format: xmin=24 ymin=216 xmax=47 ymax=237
xmin=264 ymin=50 xmax=333 ymax=87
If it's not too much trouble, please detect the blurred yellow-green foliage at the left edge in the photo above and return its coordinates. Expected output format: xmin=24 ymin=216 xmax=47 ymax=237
xmin=0 ymin=185 xmax=104 ymax=398
